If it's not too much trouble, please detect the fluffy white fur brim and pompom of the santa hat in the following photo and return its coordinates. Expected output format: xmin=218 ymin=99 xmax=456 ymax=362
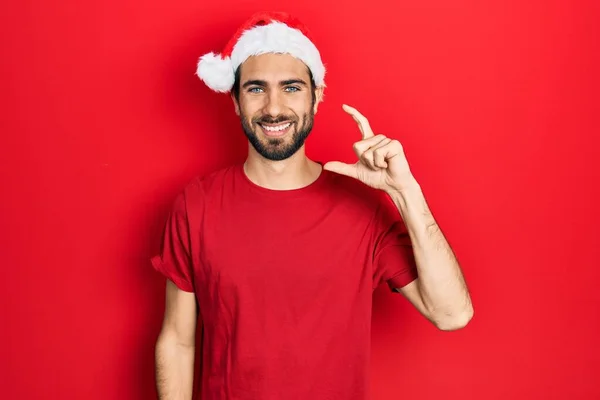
xmin=197 ymin=21 xmax=325 ymax=92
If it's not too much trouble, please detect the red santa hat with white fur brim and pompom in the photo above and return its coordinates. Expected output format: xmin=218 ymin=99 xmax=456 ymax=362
xmin=196 ymin=12 xmax=325 ymax=93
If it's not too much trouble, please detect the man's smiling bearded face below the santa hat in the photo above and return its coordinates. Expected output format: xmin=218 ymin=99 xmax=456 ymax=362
xmin=234 ymin=54 xmax=322 ymax=161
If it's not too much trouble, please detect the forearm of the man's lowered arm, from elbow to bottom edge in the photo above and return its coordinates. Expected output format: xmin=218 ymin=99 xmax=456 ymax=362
xmin=155 ymin=336 xmax=195 ymax=400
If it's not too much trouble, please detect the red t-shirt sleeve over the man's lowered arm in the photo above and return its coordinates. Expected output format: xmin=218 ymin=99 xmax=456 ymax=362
xmin=151 ymin=193 xmax=194 ymax=292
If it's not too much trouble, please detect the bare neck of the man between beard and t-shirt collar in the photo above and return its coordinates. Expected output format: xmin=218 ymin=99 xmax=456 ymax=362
xmin=244 ymin=149 xmax=322 ymax=190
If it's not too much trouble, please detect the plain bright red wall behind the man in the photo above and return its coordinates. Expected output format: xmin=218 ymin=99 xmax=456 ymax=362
xmin=0 ymin=0 xmax=600 ymax=400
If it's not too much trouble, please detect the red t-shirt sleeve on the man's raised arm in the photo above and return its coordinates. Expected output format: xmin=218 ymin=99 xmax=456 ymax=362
xmin=373 ymin=195 xmax=418 ymax=290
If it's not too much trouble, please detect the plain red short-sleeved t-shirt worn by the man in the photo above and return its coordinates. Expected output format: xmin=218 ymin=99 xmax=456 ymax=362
xmin=152 ymin=164 xmax=417 ymax=400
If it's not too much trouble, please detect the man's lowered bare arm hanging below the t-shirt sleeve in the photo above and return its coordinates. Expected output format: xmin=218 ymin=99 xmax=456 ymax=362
xmin=155 ymin=279 xmax=197 ymax=400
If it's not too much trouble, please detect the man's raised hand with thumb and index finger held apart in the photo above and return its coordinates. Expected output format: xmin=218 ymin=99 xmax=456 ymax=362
xmin=324 ymin=105 xmax=415 ymax=193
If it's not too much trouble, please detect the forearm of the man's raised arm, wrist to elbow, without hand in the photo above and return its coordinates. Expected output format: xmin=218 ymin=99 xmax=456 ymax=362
xmin=388 ymin=181 xmax=473 ymax=327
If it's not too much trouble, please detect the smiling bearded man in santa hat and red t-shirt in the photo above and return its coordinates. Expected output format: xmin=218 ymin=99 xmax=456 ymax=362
xmin=152 ymin=13 xmax=473 ymax=400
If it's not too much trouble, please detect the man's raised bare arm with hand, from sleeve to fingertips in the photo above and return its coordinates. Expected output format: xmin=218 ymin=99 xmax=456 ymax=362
xmin=324 ymin=105 xmax=473 ymax=330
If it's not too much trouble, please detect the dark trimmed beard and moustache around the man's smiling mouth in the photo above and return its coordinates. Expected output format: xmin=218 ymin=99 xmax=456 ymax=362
xmin=240 ymin=107 xmax=314 ymax=161
